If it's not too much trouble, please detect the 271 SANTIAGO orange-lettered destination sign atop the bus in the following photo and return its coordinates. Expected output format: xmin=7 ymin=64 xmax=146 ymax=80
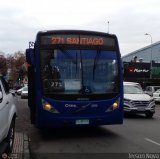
xmin=41 ymin=35 xmax=115 ymax=47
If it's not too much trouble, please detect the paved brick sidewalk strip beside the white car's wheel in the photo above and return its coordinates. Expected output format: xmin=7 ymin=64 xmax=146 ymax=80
xmin=3 ymin=132 xmax=30 ymax=159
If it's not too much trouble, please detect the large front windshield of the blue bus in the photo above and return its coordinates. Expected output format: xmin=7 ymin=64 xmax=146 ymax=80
xmin=40 ymin=47 xmax=119 ymax=94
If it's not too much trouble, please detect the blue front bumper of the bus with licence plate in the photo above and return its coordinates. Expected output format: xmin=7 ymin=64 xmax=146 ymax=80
xmin=36 ymin=111 xmax=123 ymax=128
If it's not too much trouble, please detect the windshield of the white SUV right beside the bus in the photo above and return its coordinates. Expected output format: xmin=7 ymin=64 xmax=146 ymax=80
xmin=124 ymin=85 xmax=143 ymax=94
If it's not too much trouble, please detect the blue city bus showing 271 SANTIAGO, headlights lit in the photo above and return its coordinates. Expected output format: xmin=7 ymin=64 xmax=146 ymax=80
xmin=26 ymin=30 xmax=123 ymax=128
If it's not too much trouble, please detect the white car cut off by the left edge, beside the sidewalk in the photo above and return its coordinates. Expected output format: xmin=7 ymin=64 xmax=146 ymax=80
xmin=0 ymin=76 xmax=16 ymax=154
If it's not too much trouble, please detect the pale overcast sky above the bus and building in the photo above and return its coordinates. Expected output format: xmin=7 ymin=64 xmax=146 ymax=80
xmin=0 ymin=0 xmax=160 ymax=56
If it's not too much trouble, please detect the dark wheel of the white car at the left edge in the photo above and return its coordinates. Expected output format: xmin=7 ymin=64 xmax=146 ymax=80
xmin=5 ymin=118 xmax=15 ymax=154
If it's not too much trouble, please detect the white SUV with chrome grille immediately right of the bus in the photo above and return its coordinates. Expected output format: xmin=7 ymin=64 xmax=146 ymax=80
xmin=123 ymin=82 xmax=155 ymax=118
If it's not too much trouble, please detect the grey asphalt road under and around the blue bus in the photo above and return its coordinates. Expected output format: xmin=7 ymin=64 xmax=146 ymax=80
xmin=16 ymin=97 xmax=160 ymax=159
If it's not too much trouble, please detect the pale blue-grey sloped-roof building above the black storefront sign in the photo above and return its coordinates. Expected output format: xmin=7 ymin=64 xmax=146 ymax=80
xmin=122 ymin=41 xmax=160 ymax=63
